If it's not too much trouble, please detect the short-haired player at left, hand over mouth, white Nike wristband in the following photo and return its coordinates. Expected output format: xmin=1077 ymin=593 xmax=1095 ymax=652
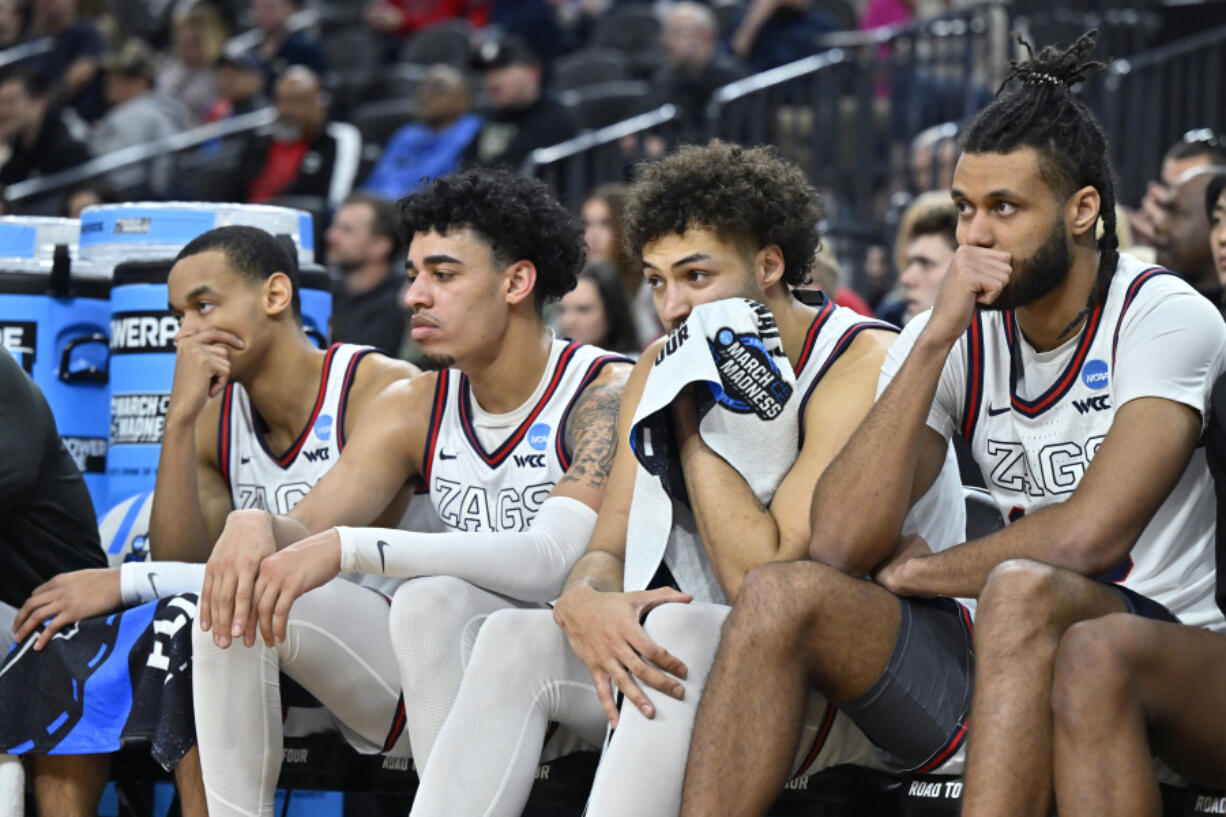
xmin=5 ymin=226 xmax=417 ymax=815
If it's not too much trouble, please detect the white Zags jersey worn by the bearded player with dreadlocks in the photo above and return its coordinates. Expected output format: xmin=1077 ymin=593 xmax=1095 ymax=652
xmin=945 ymin=254 xmax=1221 ymax=627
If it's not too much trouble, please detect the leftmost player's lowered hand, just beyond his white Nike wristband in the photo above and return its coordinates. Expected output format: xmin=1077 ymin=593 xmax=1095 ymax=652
xmin=12 ymin=568 xmax=123 ymax=650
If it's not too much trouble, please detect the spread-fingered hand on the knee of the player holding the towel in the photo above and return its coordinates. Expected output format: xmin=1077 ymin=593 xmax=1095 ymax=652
xmin=553 ymin=583 xmax=694 ymax=729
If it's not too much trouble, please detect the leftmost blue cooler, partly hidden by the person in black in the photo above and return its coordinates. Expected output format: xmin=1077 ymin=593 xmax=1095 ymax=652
xmin=0 ymin=216 xmax=110 ymax=513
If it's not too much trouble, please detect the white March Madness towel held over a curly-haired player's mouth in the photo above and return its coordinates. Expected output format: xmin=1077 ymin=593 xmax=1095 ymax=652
xmin=624 ymin=298 xmax=799 ymax=604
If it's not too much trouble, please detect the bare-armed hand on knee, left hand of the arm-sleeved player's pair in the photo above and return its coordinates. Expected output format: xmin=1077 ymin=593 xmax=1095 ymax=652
xmin=200 ymin=510 xmax=277 ymax=649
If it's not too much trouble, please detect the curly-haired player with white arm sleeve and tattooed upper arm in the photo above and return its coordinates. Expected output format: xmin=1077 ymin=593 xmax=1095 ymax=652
xmin=192 ymin=171 xmax=630 ymax=817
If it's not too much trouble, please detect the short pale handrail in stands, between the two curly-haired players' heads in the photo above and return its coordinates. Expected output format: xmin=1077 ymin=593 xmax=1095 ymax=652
xmin=521 ymin=104 xmax=679 ymax=210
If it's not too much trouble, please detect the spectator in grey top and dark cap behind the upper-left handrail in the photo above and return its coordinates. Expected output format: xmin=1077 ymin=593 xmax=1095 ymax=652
xmin=89 ymin=39 xmax=188 ymax=193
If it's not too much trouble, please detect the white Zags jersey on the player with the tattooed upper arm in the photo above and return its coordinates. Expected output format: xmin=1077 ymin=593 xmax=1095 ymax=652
xmin=422 ymin=340 xmax=630 ymax=531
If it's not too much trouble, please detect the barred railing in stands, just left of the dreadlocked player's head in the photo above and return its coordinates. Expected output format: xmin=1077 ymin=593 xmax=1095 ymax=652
xmin=706 ymin=1 xmax=1009 ymax=280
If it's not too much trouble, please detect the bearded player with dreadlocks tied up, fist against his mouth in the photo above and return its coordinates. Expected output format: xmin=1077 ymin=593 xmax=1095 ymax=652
xmin=682 ymin=32 xmax=1226 ymax=816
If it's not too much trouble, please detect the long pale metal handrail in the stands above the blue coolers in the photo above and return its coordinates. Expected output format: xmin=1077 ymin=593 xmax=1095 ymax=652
xmin=4 ymin=107 xmax=277 ymax=211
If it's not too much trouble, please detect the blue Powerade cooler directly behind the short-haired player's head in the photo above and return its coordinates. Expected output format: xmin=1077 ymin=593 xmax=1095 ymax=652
xmin=81 ymin=202 xmax=332 ymax=522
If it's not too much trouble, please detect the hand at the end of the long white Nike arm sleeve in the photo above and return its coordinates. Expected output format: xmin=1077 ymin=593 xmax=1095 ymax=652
xmin=255 ymin=527 xmax=341 ymax=646
